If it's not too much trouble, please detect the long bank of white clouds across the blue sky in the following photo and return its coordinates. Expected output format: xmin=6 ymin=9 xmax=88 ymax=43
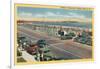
xmin=19 ymin=12 xmax=86 ymax=18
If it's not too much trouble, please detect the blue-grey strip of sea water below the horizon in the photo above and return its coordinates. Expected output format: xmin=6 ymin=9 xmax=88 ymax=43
xmin=33 ymin=22 xmax=92 ymax=29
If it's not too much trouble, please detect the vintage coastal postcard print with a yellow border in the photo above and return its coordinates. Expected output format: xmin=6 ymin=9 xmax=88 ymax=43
xmin=14 ymin=4 xmax=94 ymax=64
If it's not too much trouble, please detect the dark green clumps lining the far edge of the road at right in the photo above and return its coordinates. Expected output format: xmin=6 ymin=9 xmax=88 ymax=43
xmin=58 ymin=30 xmax=92 ymax=46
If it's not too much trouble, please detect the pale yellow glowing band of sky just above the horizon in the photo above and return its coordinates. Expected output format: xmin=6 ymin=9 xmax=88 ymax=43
xmin=17 ymin=18 xmax=92 ymax=23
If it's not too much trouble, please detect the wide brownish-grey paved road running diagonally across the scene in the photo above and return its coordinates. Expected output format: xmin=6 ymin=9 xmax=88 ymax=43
xmin=18 ymin=26 xmax=92 ymax=59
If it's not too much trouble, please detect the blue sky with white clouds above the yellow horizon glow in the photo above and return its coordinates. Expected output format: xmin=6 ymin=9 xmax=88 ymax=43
xmin=17 ymin=7 xmax=92 ymax=20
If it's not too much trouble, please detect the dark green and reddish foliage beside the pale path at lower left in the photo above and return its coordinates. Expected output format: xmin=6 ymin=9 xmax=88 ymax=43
xmin=17 ymin=37 xmax=53 ymax=61
